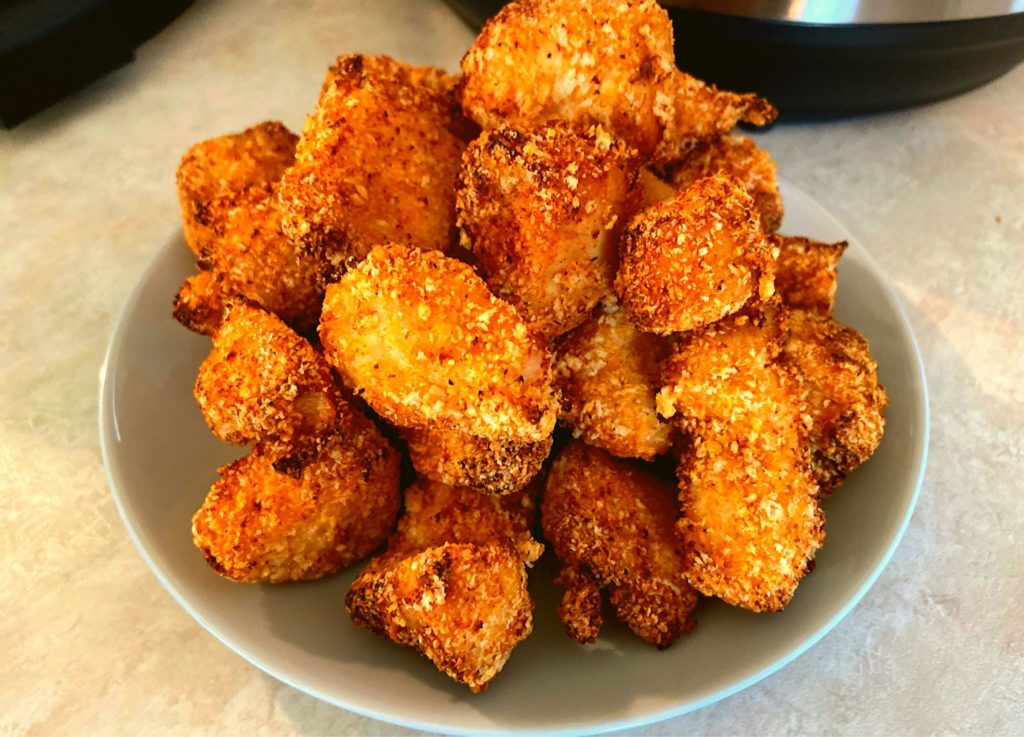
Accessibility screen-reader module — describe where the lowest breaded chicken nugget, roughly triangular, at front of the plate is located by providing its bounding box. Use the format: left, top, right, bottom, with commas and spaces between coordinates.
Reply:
345, 544, 534, 693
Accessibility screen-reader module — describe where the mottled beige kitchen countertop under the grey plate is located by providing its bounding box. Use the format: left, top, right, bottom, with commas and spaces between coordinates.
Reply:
0, 0, 1024, 735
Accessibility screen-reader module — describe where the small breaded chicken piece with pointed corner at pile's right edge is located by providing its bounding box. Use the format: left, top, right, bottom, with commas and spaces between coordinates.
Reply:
775, 235, 847, 315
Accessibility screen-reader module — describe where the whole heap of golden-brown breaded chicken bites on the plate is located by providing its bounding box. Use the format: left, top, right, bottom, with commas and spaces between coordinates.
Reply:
174, 0, 887, 691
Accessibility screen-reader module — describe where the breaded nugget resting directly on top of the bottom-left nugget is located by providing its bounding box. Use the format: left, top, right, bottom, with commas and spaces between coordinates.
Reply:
195, 303, 345, 456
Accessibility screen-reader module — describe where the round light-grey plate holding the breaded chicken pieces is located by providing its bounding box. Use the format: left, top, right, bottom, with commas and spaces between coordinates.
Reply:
99, 184, 928, 735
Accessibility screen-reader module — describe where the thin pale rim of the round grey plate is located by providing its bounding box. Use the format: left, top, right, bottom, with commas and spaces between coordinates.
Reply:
97, 177, 931, 737
